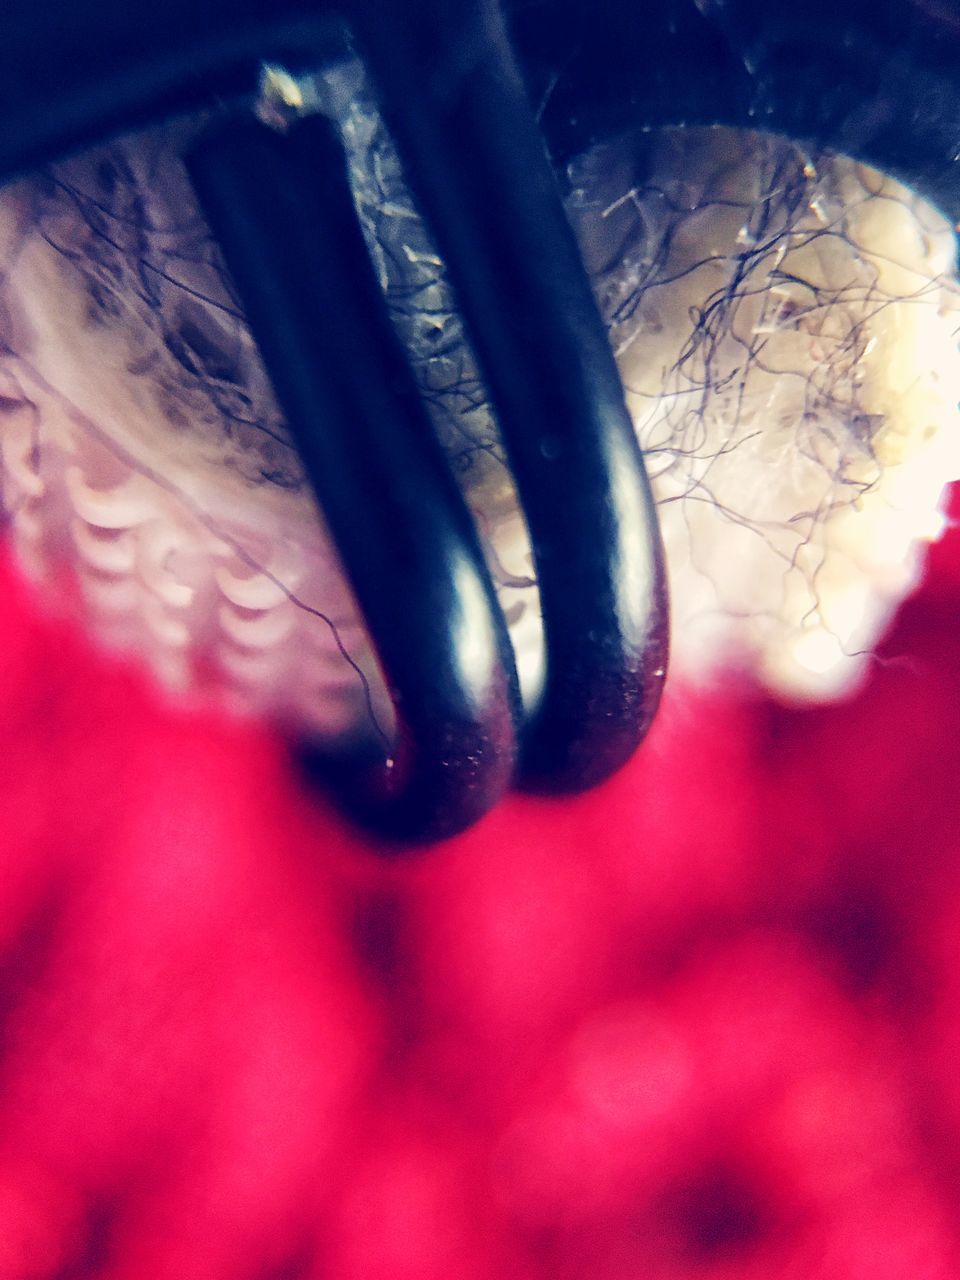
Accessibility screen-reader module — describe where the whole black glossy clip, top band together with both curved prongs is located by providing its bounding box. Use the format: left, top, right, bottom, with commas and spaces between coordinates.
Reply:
0, 0, 960, 840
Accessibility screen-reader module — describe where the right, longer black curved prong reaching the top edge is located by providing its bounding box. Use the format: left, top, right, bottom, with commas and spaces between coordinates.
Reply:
355, 0, 667, 790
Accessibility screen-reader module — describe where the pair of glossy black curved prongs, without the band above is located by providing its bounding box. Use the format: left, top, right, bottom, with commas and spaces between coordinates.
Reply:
188, 4, 667, 837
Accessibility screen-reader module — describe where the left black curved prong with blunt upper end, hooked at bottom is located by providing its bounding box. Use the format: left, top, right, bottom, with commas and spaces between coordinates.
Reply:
188, 116, 520, 840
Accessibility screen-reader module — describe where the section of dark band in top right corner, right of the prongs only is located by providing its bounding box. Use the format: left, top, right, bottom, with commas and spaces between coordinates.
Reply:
519, 0, 960, 220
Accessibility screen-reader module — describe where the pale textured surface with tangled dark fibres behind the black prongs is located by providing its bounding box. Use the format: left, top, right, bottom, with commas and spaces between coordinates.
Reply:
0, 74, 960, 736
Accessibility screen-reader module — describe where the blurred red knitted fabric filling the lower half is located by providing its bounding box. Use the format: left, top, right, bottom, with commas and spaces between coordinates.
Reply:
0, 491, 960, 1280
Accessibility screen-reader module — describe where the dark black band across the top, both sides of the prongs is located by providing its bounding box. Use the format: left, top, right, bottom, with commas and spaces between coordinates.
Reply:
0, 0, 960, 218
